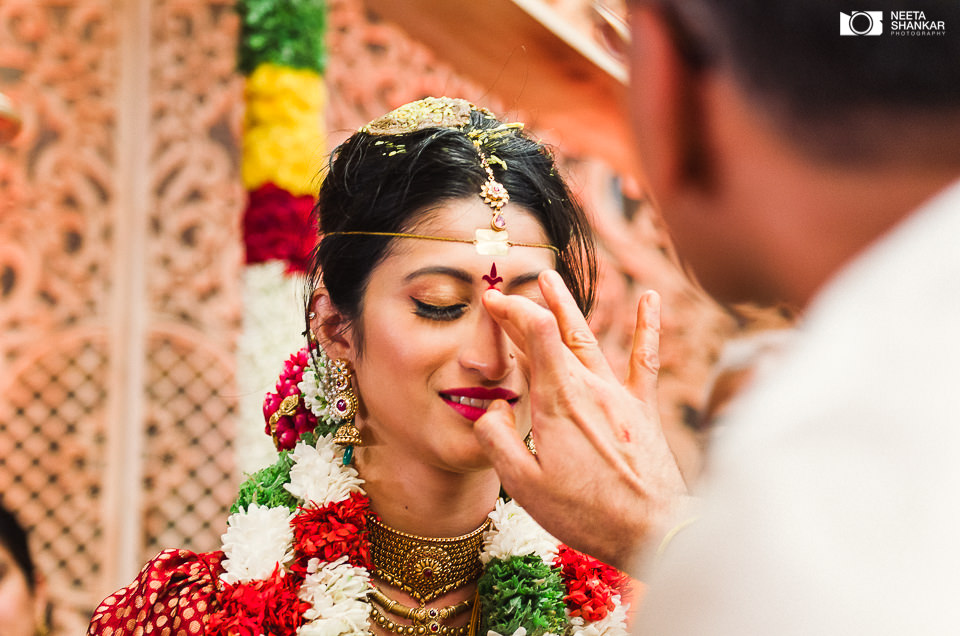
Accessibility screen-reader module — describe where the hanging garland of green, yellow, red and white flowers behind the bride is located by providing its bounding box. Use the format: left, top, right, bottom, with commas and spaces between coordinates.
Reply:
235, 0, 327, 472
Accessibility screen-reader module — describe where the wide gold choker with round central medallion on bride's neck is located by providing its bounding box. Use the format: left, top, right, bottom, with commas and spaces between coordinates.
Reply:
367, 515, 490, 605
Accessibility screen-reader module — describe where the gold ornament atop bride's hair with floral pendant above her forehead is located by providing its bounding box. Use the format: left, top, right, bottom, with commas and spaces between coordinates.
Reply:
360, 97, 523, 232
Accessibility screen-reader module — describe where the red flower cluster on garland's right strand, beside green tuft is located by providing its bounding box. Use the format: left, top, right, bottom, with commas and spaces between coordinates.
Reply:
553, 545, 630, 622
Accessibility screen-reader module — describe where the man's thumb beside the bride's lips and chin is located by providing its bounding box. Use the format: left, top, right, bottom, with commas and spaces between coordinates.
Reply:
473, 400, 540, 496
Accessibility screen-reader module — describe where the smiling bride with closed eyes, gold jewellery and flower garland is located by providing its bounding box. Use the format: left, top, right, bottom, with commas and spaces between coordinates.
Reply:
89, 98, 627, 636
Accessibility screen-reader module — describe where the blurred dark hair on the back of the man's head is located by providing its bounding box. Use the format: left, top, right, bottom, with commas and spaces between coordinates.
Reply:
635, 0, 960, 161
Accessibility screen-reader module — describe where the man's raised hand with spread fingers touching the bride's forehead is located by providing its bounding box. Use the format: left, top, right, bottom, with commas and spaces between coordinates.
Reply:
475, 271, 686, 569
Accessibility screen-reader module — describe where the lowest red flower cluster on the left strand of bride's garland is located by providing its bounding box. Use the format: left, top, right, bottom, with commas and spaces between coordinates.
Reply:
207, 566, 310, 636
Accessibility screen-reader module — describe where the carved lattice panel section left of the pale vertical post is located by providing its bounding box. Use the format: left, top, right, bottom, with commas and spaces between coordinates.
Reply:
0, 2, 118, 633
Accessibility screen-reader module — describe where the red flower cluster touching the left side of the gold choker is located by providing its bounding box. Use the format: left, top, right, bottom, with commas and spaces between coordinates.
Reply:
292, 492, 373, 573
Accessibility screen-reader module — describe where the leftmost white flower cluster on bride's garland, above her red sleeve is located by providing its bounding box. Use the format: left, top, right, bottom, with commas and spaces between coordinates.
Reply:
220, 503, 293, 584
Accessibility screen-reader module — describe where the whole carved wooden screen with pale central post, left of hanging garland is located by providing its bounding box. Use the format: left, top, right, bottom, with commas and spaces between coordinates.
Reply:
0, 0, 243, 634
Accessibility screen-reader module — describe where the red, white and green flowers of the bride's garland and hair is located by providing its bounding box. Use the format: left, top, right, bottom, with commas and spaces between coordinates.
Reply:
208, 348, 627, 636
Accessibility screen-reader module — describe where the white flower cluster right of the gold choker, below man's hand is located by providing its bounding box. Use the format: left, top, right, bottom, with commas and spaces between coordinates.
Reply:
480, 499, 559, 564
